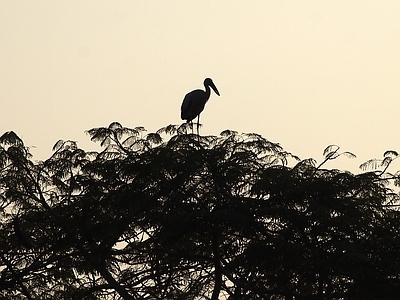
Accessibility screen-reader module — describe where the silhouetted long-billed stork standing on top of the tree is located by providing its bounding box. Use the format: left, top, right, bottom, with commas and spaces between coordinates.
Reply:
181, 78, 219, 135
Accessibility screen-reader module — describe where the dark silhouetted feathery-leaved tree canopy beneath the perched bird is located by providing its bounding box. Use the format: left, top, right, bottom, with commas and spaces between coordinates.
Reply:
0, 122, 400, 300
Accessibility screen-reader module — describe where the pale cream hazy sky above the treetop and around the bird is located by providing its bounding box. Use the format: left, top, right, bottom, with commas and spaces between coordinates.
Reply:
0, 0, 400, 169
